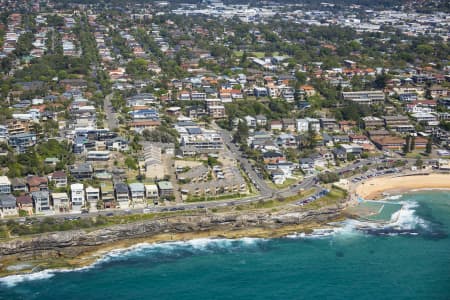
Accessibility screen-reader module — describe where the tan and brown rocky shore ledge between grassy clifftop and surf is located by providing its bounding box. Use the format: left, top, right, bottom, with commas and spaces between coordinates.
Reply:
0, 207, 345, 278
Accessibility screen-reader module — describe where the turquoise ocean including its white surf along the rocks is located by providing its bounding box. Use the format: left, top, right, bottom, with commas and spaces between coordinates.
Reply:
0, 191, 450, 300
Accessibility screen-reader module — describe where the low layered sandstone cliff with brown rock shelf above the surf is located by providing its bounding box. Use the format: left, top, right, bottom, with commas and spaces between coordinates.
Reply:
0, 206, 341, 275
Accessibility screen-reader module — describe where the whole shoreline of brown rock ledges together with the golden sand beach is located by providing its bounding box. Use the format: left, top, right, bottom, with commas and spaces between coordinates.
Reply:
0, 174, 450, 278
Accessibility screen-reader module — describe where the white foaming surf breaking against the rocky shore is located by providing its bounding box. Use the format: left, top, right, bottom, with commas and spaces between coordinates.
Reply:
0, 196, 445, 287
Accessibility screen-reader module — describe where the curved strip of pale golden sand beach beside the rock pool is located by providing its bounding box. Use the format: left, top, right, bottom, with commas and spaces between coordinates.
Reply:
355, 173, 450, 200
